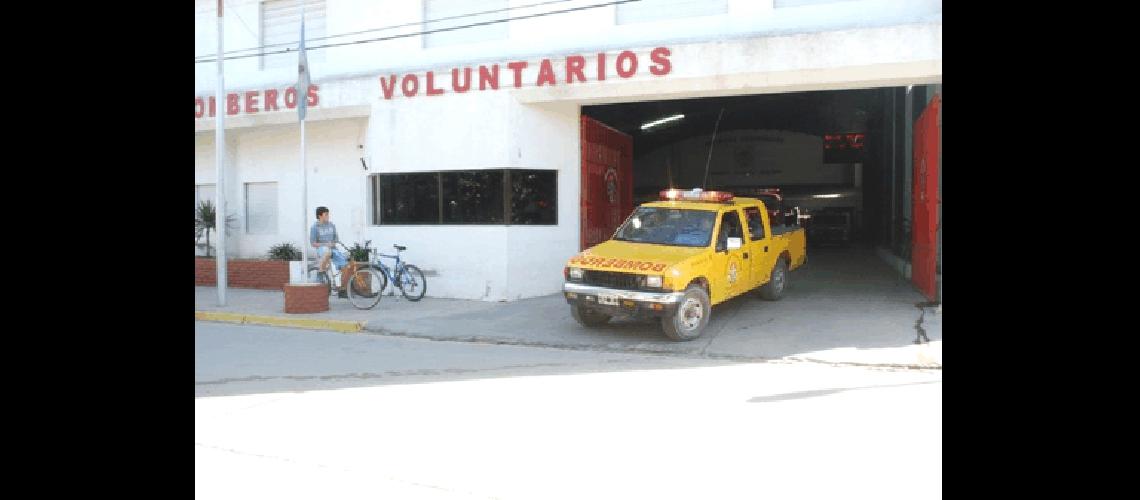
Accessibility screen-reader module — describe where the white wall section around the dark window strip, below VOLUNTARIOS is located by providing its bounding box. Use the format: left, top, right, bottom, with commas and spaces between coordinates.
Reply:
365, 93, 580, 301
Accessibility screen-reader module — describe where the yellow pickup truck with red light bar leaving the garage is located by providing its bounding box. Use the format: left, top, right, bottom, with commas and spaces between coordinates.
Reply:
562, 189, 807, 341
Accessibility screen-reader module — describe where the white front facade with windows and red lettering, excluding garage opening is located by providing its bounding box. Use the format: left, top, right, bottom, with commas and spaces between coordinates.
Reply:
195, 0, 942, 301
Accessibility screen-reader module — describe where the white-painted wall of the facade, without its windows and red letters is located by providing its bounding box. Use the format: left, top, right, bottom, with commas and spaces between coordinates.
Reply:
195, 0, 942, 301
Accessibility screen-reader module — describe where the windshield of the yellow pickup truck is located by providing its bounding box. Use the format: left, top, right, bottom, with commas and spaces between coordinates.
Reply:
613, 206, 716, 246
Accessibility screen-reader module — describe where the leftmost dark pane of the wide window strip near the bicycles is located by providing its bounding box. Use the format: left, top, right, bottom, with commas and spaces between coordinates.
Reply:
378, 173, 439, 224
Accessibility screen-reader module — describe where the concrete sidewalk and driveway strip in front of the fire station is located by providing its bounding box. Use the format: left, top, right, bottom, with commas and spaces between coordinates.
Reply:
194, 255, 942, 368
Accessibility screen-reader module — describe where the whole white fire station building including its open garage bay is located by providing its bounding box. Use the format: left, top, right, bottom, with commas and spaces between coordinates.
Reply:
194, 0, 942, 301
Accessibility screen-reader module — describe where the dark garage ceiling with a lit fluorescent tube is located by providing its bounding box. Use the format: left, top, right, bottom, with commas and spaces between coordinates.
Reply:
581, 89, 882, 157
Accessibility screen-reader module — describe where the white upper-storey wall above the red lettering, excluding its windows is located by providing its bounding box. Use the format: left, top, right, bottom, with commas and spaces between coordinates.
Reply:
195, 0, 942, 92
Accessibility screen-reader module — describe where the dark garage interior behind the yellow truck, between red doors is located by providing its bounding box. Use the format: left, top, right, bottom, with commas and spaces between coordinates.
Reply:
581, 85, 942, 301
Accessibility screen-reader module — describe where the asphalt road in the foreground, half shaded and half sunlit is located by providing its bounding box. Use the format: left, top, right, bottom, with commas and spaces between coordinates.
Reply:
195, 322, 942, 499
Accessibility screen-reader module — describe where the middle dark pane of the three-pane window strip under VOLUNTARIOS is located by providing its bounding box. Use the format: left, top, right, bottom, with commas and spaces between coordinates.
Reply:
440, 170, 504, 224
